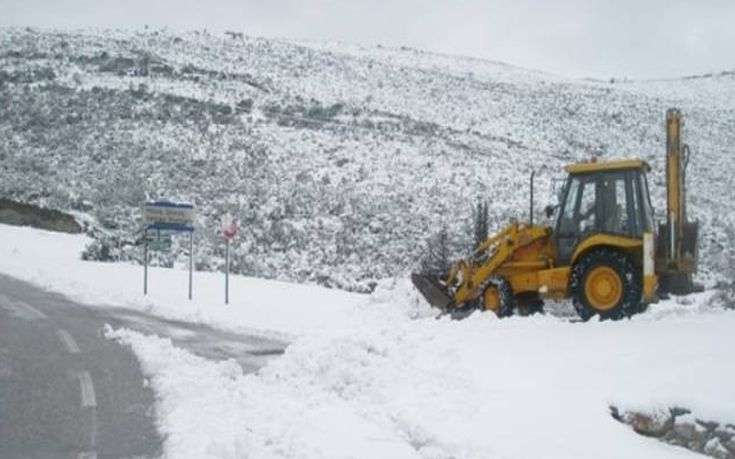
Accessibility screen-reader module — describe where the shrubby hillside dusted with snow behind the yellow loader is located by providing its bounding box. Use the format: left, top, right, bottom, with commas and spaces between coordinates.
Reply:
0, 29, 735, 291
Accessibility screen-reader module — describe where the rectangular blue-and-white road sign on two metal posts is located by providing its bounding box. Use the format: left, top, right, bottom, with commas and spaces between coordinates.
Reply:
143, 201, 194, 300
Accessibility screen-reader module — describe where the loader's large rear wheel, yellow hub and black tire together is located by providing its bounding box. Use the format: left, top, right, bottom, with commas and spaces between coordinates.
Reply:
571, 249, 643, 320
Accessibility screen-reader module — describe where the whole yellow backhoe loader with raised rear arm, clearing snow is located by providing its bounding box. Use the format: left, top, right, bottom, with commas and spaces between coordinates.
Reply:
412, 109, 698, 320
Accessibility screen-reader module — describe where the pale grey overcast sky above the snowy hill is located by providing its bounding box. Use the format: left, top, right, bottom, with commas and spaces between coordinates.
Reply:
0, 0, 735, 78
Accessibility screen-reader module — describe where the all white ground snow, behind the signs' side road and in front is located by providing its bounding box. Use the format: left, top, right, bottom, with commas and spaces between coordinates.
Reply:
0, 225, 735, 458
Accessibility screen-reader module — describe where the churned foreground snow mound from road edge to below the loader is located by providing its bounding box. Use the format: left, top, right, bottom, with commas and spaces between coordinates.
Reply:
108, 283, 735, 458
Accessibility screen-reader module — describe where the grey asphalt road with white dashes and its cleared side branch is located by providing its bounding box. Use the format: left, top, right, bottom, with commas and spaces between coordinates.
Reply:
0, 275, 286, 459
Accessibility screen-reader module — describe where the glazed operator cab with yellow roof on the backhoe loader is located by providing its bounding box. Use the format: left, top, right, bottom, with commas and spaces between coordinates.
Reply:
554, 160, 653, 265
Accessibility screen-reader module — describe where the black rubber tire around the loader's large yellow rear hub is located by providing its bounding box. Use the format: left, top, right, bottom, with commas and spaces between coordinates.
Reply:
570, 249, 643, 321
